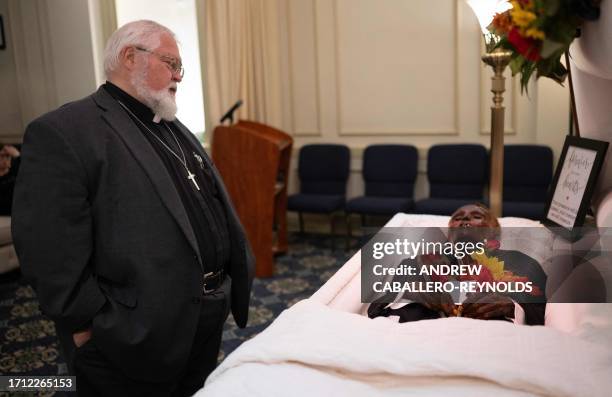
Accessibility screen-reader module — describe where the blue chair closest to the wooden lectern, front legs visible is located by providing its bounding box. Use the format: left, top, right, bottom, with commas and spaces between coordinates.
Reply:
287, 144, 351, 249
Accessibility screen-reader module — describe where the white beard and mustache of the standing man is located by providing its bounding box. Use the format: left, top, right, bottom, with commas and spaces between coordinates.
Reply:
131, 67, 177, 121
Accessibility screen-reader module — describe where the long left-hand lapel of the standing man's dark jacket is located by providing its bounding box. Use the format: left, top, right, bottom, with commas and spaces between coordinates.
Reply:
93, 87, 202, 266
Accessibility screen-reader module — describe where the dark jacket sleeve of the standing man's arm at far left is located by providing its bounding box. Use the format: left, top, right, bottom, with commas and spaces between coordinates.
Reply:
12, 121, 106, 331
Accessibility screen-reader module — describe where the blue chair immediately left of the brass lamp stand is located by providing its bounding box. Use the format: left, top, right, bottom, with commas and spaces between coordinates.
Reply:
414, 144, 488, 215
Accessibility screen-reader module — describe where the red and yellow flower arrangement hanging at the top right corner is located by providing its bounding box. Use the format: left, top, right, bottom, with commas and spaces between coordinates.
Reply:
488, 0, 600, 90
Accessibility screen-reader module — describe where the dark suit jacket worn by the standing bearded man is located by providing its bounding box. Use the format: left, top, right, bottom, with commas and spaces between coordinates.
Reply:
12, 88, 254, 380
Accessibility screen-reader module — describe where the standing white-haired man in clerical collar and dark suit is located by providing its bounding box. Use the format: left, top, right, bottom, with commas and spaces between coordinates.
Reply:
13, 21, 253, 396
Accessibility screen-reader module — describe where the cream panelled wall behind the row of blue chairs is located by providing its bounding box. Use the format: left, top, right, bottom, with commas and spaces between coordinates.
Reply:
280, 0, 568, 198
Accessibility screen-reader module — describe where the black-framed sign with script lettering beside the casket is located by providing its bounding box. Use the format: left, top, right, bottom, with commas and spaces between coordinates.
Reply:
542, 136, 608, 233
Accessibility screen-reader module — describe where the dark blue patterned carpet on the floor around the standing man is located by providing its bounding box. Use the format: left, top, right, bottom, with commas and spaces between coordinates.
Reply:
0, 233, 352, 386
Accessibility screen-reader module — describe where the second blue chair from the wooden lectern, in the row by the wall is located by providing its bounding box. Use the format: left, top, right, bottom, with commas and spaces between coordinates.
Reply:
346, 145, 419, 222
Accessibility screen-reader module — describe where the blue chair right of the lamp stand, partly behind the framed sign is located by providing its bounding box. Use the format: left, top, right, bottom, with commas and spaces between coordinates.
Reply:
502, 145, 553, 220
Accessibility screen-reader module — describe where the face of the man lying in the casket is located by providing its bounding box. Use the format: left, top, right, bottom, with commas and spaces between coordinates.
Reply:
448, 204, 499, 242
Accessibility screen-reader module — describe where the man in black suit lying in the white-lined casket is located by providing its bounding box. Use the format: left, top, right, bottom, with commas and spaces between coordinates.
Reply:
368, 204, 546, 325
